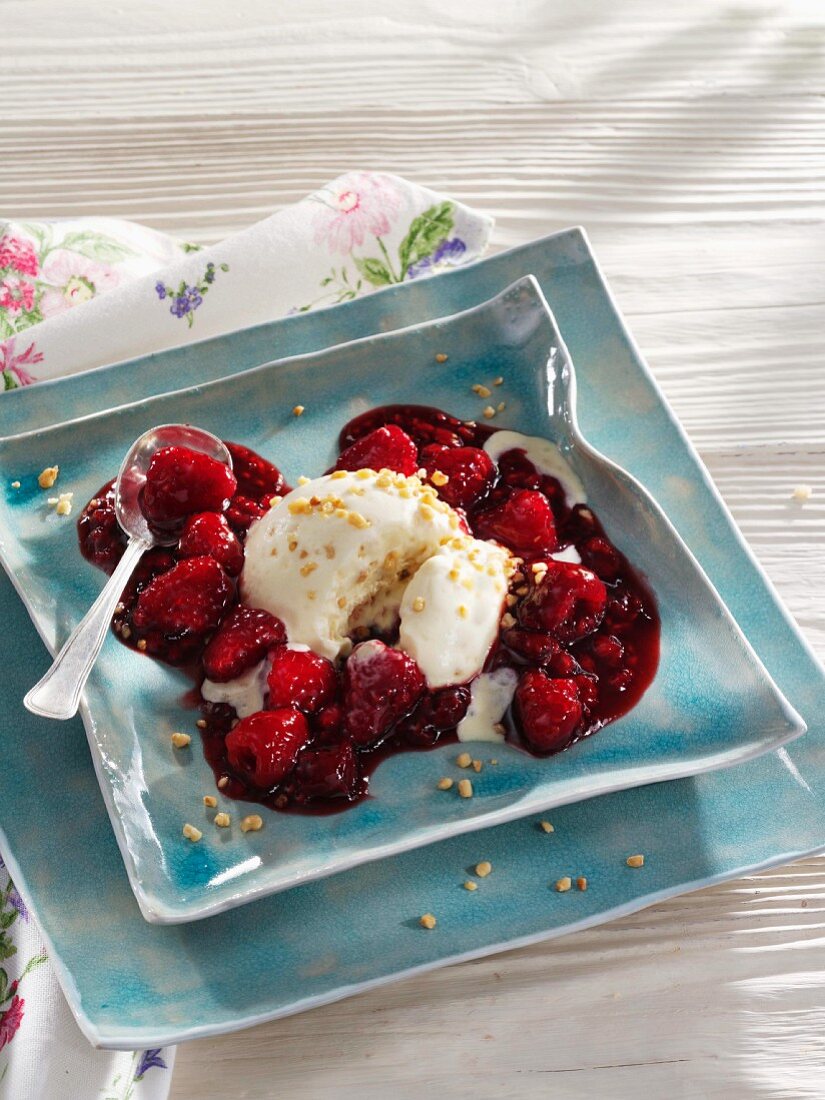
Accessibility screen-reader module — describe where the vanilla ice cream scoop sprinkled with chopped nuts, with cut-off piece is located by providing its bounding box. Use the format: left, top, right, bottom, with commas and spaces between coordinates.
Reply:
241, 470, 514, 688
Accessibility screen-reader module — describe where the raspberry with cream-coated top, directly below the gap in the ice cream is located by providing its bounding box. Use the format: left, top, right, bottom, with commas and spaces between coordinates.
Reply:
343, 639, 425, 746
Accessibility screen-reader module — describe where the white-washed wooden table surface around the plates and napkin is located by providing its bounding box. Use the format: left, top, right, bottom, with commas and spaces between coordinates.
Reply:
6, 0, 825, 1100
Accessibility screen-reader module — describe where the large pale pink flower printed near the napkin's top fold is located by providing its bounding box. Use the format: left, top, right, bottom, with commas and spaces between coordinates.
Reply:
312, 172, 402, 254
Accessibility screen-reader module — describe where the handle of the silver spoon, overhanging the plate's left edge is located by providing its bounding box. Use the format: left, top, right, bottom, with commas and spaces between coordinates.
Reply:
23, 538, 150, 719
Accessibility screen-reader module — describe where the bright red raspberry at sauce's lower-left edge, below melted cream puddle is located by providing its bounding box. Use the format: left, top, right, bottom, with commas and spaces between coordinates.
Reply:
227, 706, 309, 790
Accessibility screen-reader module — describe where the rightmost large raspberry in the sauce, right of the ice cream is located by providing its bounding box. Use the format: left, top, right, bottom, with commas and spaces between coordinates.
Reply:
518, 561, 607, 642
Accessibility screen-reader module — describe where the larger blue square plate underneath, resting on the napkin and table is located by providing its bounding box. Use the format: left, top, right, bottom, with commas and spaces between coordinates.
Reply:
0, 231, 825, 1049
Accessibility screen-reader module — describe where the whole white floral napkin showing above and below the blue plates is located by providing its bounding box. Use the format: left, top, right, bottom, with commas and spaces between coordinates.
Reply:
0, 172, 492, 1100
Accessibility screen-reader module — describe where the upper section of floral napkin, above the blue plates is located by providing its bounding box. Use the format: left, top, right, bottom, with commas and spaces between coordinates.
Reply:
0, 172, 492, 391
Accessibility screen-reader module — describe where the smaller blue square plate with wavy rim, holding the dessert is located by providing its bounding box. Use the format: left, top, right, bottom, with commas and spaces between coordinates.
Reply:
0, 278, 804, 923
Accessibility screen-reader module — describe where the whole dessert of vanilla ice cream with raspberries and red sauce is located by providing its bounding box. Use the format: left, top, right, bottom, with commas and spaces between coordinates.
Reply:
78, 406, 659, 812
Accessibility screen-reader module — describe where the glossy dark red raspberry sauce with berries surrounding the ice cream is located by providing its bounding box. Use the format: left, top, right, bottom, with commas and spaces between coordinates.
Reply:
77, 405, 660, 813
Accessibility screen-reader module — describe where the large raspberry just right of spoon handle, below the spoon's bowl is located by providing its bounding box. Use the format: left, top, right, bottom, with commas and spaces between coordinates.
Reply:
132, 557, 234, 639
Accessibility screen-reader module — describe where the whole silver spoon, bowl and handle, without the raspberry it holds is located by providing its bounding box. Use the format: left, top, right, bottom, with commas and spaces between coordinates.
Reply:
23, 424, 232, 719
